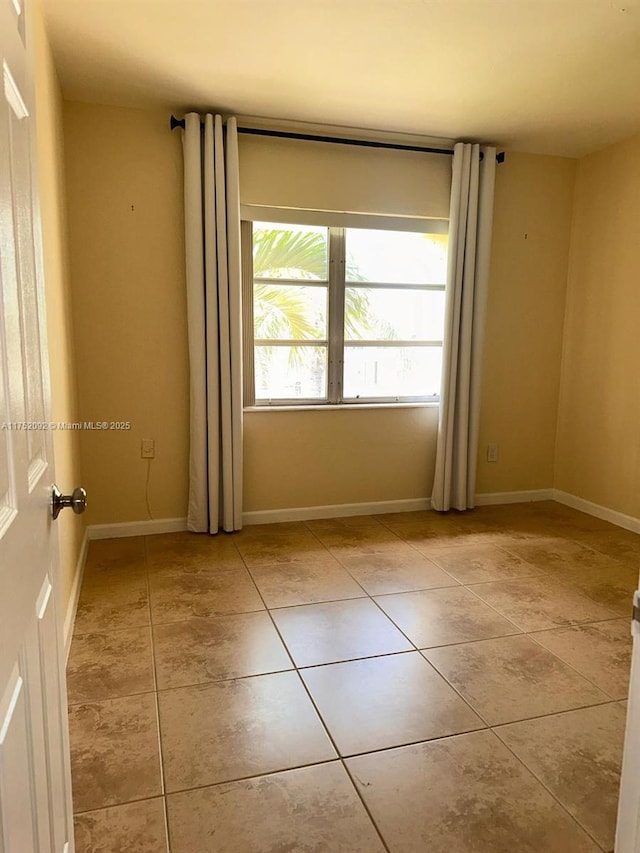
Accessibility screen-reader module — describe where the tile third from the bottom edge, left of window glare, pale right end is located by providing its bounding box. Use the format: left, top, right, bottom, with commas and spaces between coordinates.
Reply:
153, 612, 293, 690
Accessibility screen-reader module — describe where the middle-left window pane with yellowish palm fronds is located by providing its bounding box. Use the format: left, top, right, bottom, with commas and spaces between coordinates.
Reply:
253, 282, 328, 341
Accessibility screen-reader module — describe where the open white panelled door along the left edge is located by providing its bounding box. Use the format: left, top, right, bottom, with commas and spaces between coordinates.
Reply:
0, 0, 73, 853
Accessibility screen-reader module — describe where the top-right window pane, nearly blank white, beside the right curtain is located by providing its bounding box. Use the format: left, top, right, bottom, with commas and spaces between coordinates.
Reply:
345, 228, 449, 284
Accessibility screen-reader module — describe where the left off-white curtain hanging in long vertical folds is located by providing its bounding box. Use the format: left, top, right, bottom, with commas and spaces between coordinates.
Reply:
182, 113, 242, 533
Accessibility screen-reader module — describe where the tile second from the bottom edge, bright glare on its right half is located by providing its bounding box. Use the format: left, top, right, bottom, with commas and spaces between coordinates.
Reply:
158, 672, 335, 792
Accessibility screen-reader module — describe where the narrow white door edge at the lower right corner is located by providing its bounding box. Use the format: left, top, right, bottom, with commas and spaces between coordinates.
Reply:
616, 592, 640, 853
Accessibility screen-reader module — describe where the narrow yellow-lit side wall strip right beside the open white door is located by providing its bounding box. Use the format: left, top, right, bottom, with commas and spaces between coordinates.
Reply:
33, 6, 84, 613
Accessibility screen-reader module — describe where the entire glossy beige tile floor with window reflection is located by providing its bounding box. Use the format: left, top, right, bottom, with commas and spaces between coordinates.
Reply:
68, 503, 640, 853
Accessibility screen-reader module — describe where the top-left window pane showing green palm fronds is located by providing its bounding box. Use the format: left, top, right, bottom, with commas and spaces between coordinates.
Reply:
253, 222, 329, 281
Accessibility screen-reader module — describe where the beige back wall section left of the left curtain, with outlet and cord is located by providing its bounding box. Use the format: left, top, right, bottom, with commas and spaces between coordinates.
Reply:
64, 103, 189, 524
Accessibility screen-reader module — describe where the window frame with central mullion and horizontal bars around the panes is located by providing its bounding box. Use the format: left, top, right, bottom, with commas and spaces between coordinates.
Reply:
241, 211, 449, 409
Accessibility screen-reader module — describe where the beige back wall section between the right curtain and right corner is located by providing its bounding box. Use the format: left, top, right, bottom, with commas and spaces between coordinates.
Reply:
477, 152, 576, 493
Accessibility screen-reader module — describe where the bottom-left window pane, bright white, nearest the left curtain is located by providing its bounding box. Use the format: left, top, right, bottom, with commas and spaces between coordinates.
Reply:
255, 346, 327, 400
